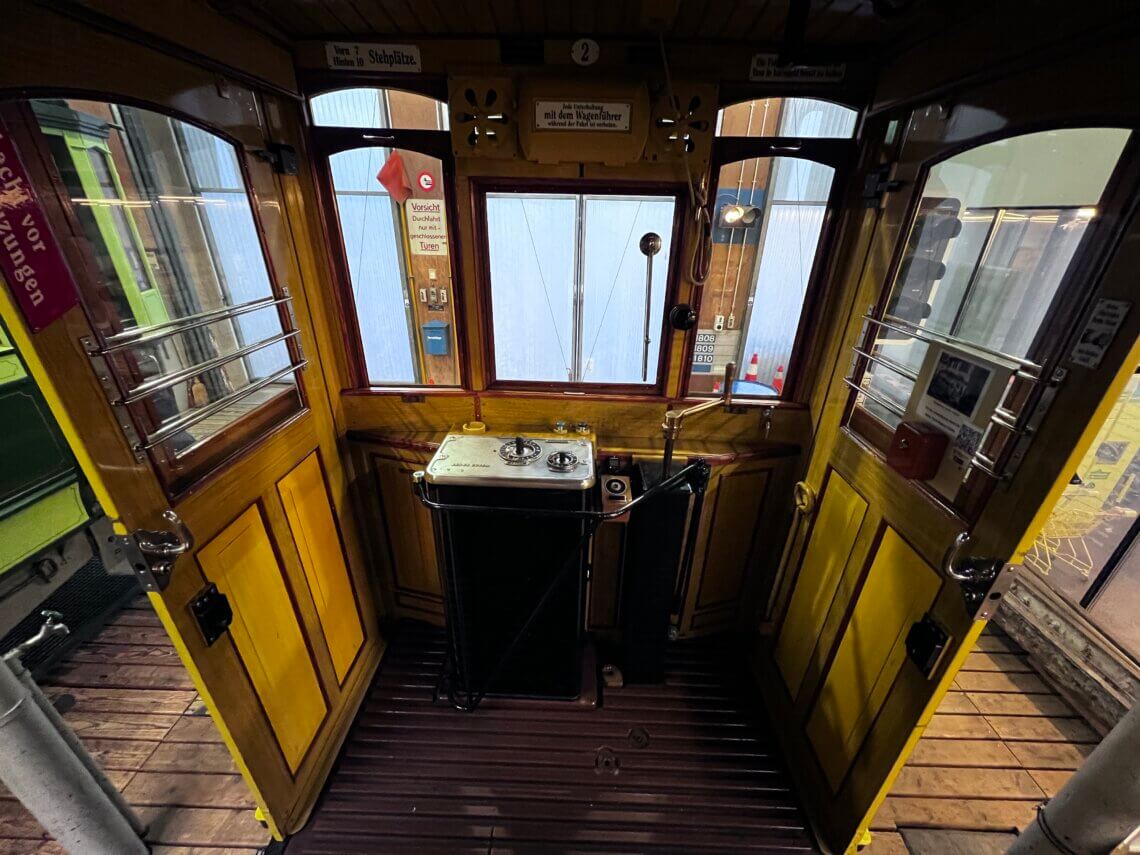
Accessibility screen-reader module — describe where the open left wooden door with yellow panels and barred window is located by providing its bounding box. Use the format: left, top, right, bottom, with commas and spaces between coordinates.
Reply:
0, 78, 383, 838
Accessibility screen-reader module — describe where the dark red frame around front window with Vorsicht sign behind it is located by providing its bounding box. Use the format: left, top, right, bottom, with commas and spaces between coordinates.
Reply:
304, 93, 470, 396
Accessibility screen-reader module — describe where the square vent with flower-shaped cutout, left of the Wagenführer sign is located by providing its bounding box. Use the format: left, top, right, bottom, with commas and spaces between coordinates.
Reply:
448, 78, 519, 157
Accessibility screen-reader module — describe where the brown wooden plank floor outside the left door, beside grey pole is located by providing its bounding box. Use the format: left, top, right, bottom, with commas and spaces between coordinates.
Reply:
0, 599, 269, 855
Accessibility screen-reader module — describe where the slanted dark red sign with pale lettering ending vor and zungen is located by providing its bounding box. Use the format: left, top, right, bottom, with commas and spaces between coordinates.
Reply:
0, 122, 79, 332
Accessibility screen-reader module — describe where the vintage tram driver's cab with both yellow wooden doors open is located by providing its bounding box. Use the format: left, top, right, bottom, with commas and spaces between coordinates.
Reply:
0, 0, 1140, 853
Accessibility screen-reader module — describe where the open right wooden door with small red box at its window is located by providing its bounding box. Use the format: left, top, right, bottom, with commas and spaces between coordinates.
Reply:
757, 58, 1140, 852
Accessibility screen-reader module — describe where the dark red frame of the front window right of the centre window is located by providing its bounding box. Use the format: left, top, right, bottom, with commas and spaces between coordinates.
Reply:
681, 132, 860, 407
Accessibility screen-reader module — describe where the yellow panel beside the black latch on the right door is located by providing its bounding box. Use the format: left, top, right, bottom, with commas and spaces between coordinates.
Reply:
807, 528, 942, 791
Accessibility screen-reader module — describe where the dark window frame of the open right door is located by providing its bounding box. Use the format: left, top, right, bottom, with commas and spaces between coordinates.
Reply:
840, 120, 1140, 523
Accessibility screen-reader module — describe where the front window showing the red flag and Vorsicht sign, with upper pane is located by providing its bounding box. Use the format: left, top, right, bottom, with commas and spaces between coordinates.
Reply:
310, 89, 459, 388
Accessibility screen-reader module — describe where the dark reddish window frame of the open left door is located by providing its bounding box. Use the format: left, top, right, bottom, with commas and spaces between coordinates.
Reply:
0, 96, 309, 500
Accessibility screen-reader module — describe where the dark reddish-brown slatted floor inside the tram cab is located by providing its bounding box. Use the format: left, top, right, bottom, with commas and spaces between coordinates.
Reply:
286, 625, 812, 855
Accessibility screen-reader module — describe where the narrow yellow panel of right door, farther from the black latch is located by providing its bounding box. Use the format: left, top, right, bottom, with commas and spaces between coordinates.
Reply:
775, 471, 866, 699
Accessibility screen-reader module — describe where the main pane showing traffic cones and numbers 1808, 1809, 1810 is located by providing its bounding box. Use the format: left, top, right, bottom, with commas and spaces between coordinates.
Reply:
689, 157, 834, 398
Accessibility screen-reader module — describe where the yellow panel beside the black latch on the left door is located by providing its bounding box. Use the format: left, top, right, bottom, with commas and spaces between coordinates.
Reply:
198, 505, 327, 771
